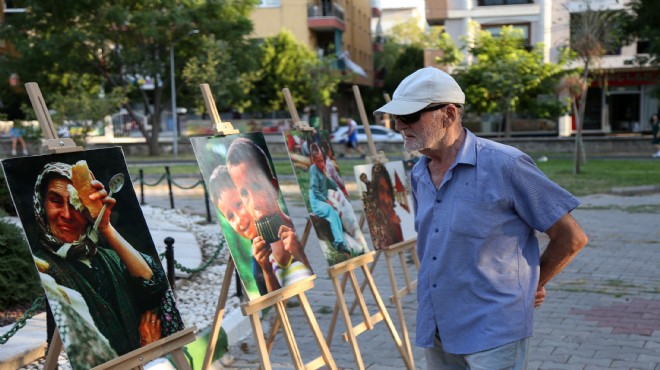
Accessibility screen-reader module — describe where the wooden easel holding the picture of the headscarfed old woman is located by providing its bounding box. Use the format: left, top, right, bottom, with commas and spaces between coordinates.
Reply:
25, 82, 197, 370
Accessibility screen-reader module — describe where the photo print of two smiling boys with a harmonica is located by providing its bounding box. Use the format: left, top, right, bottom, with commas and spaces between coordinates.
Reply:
191, 132, 313, 300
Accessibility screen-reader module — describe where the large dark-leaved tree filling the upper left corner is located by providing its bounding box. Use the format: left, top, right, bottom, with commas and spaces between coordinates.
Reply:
0, 0, 254, 155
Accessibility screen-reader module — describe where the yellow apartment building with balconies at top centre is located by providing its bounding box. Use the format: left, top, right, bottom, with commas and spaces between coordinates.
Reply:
252, 0, 373, 86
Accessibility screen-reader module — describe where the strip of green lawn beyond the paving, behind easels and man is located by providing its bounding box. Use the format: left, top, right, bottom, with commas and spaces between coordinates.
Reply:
126, 153, 660, 196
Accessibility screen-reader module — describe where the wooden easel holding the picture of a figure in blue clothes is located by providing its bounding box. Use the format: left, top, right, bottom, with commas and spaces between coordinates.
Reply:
282, 88, 414, 370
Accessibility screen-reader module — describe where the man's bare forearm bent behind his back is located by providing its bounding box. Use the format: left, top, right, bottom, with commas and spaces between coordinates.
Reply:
536, 213, 589, 306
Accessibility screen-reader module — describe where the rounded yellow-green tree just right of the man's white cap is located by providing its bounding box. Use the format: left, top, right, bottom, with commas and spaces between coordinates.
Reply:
456, 26, 567, 137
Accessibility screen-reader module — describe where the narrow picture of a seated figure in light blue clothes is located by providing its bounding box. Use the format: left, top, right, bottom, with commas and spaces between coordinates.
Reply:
284, 130, 369, 266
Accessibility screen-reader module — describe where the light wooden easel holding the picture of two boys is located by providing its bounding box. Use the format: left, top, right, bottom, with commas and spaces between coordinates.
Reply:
200, 84, 337, 370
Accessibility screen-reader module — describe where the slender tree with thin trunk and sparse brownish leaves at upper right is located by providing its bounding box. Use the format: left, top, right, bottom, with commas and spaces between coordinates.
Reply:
570, 0, 621, 174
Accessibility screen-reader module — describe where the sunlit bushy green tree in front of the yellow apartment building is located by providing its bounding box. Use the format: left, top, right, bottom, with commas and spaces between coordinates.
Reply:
247, 30, 342, 125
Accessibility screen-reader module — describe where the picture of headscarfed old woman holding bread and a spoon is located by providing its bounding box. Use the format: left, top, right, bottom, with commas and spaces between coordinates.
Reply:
2, 148, 184, 370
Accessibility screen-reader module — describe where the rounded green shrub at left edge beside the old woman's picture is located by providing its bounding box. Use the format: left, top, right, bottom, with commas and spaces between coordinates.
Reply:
0, 215, 44, 311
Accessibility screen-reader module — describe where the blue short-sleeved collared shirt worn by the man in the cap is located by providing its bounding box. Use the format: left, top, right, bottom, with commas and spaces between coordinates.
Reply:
412, 129, 579, 354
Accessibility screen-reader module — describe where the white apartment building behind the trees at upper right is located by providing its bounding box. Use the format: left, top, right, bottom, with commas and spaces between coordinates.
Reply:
426, 0, 660, 134
